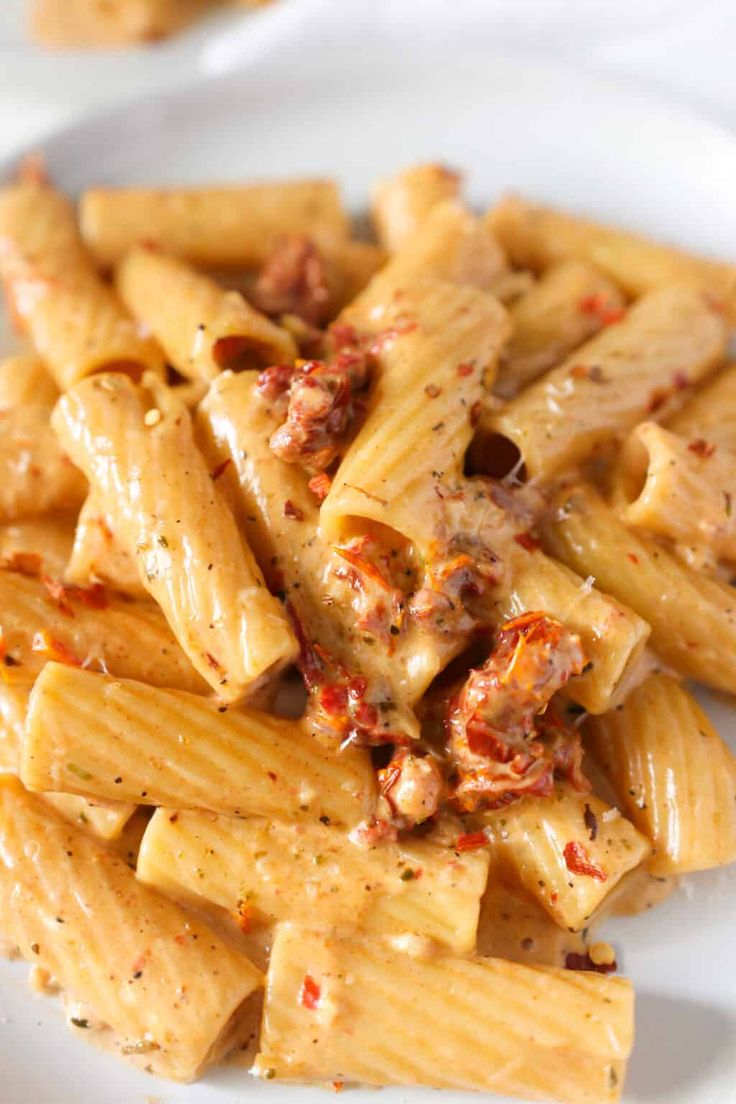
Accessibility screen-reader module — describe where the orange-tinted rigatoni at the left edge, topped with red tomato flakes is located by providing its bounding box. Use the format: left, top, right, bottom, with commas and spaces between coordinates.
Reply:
0, 571, 206, 693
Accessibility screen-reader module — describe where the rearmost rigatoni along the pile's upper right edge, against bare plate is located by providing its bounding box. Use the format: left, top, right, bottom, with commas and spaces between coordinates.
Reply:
488, 195, 736, 316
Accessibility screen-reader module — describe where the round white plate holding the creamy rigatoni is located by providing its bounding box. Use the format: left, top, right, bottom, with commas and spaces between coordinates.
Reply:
0, 10, 736, 1104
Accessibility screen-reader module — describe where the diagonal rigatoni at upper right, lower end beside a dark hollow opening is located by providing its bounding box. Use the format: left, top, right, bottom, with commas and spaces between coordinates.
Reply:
484, 286, 728, 479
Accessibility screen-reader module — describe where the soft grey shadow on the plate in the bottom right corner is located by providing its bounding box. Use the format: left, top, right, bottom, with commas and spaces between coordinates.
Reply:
627, 992, 736, 1104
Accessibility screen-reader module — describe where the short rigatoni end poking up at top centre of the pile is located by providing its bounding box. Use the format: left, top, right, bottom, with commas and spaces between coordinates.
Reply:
371, 162, 462, 253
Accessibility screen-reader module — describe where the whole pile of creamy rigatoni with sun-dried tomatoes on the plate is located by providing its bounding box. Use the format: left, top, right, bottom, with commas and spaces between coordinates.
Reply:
0, 162, 736, 1104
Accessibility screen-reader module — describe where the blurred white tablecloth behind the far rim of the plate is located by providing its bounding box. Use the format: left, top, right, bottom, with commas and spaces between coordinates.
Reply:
0, 0, 736, 157
